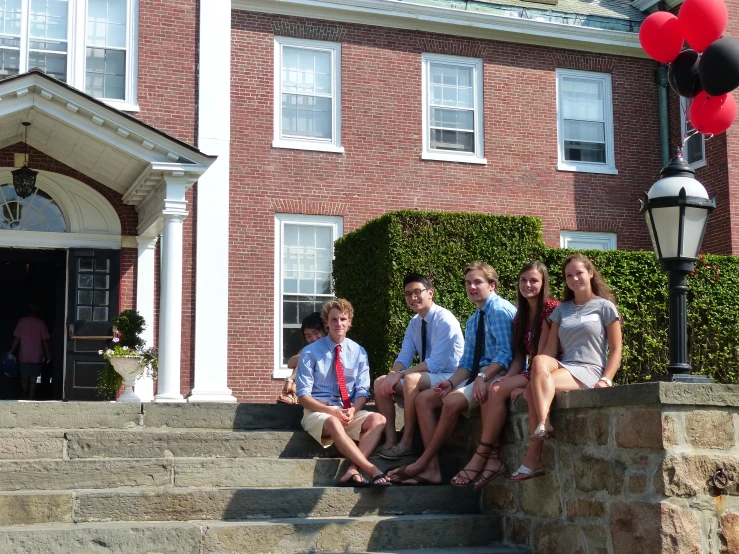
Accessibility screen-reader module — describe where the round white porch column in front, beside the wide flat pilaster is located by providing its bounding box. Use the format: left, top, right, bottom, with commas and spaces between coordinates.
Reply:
155, 181, 187, 402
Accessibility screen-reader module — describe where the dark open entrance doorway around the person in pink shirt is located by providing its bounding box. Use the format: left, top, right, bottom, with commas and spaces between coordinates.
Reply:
0, 248, 67, 400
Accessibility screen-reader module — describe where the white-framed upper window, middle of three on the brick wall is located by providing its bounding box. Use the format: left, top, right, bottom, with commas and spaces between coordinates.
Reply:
421, 54, 487, 164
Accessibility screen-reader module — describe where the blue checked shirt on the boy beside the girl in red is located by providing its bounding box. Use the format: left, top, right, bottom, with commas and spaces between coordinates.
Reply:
459, 293, 516, 373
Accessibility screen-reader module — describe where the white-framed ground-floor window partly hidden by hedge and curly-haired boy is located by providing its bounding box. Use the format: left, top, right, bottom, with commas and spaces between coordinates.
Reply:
274, 214, 344, 378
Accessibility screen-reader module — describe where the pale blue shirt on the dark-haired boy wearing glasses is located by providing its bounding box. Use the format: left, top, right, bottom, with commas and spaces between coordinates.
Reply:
395, 304, 464, 373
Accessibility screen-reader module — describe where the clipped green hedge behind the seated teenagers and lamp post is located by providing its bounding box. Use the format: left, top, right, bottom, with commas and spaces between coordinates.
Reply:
333, 211, 739, 383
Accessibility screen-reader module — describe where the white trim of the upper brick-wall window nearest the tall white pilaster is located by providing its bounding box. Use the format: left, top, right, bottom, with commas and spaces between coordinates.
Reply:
272, 37, 344, 154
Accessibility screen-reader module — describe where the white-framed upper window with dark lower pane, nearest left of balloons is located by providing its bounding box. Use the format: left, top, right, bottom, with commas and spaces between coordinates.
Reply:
556, 69, 618, 175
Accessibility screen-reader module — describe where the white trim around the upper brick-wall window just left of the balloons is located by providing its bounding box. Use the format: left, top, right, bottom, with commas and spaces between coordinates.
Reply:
556, 69, 618, 175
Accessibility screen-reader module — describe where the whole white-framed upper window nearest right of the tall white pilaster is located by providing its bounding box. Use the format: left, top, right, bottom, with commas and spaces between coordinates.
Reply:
272, 37, 344, 153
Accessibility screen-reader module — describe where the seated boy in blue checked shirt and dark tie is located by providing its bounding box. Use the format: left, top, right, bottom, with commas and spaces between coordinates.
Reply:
388, 262, 516, 485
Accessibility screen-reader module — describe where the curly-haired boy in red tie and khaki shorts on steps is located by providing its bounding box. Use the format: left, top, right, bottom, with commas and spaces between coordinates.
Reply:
297, 298, 391, 487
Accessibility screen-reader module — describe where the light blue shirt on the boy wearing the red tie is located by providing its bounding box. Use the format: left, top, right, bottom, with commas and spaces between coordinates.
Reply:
295, 337, 370, 406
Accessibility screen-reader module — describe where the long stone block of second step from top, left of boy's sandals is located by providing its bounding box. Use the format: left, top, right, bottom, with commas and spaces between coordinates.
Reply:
66, 427, 338, 459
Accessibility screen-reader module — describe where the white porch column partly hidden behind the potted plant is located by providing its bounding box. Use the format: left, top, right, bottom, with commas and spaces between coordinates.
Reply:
133, 237, 158, 402
